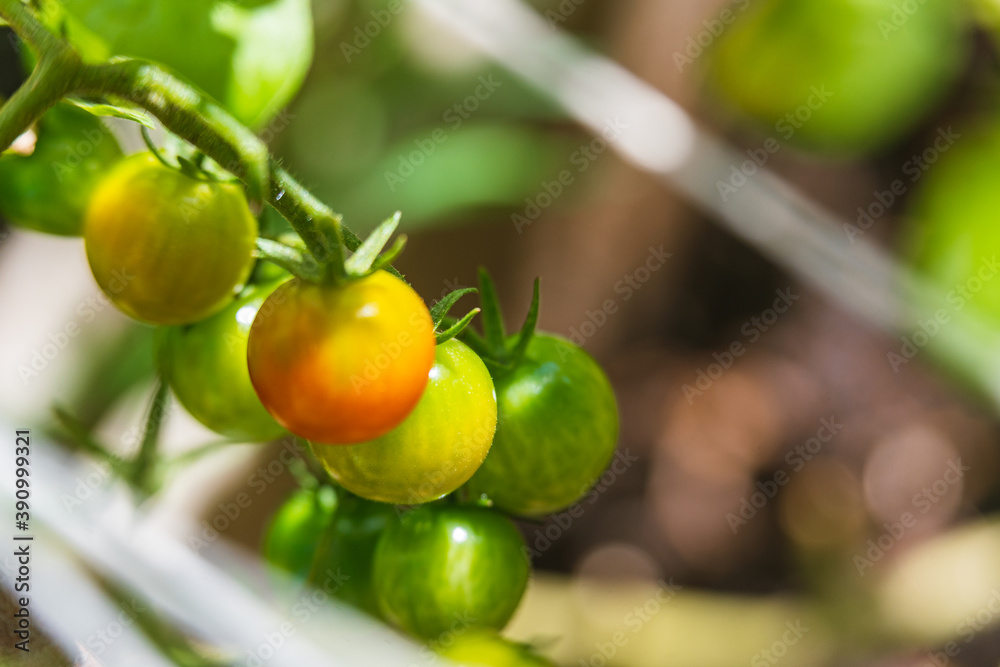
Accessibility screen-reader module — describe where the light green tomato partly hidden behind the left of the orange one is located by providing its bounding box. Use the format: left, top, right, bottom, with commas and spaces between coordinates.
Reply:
160, 284, 286, 442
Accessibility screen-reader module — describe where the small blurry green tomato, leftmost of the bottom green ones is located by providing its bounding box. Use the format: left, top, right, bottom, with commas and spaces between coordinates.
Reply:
264, 486, 337, 581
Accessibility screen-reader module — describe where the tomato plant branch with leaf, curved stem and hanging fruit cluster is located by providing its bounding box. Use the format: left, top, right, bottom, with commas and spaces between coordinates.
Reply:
0, 0, 632, 667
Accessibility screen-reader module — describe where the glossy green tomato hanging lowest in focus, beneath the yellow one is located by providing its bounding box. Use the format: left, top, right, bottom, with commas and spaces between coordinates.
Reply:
372, 503, 530, 639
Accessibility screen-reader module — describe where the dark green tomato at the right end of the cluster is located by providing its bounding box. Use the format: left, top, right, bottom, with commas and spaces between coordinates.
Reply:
469, 334, 618, 517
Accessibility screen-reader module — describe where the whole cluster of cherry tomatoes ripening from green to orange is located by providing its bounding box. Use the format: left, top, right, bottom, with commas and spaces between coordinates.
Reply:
0, 107, 618, 665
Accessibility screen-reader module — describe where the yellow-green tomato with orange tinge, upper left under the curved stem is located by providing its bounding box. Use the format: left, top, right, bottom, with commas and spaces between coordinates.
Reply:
84, 153, 257, 325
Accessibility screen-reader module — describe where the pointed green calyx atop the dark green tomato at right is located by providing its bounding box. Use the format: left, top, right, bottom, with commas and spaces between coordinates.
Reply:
461, 268, 540, 377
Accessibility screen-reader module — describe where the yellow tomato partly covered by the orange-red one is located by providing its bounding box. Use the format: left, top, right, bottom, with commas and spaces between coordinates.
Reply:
313, 339, 497, 505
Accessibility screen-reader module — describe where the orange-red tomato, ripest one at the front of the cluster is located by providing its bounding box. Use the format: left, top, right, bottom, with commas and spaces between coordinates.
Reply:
248, 271, 435, 445
